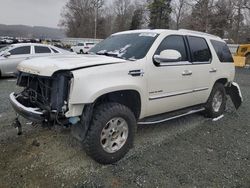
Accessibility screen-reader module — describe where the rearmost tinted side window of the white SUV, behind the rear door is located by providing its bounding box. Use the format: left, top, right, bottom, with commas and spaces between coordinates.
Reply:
211, 40, 234, 63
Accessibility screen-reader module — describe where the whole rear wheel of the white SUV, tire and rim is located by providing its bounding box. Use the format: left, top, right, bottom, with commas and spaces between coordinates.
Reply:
205, 83, 227, 118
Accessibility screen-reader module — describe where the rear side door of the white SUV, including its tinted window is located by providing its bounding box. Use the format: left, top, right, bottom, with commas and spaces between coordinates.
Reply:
187, 36, 217, 104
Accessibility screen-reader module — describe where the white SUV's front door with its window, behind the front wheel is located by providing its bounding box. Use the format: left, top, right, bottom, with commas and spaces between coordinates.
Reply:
147, 35, 195, 116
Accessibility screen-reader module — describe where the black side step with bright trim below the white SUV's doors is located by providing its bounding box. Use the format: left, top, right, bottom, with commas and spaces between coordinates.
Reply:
137, 106, 205, 125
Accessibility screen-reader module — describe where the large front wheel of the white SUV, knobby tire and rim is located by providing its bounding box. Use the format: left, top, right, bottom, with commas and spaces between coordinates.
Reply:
84, 103, 136, 164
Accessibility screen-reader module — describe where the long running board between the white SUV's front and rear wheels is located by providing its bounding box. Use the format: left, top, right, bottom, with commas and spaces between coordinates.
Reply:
137, 107, 205, 125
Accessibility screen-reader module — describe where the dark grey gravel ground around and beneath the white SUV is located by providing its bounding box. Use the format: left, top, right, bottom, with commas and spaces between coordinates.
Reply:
0, 69, 250, 188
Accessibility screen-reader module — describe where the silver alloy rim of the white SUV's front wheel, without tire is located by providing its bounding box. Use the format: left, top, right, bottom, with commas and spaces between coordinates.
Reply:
100, 117, 128, 153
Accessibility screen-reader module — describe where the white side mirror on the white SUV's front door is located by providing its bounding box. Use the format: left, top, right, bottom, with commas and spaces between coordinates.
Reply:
154, 50, 182, 63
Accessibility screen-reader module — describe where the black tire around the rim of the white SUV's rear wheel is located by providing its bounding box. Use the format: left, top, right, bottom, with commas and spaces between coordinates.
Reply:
205, 83, 227, 118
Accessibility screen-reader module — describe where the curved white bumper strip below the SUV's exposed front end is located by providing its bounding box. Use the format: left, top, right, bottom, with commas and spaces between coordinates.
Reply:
10, 93, 45, 122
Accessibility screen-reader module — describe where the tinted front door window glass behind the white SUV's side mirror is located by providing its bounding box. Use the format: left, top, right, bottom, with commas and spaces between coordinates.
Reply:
155, 35, 187, 61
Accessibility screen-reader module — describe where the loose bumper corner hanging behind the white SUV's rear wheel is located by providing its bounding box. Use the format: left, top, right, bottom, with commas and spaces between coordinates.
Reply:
226, 82, 243, 109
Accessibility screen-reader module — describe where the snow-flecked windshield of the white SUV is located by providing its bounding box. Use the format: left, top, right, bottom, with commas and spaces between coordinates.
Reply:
89, 32, 158, 60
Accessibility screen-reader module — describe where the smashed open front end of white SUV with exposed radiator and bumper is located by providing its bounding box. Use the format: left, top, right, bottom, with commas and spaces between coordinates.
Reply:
10, 72, 73, 124
